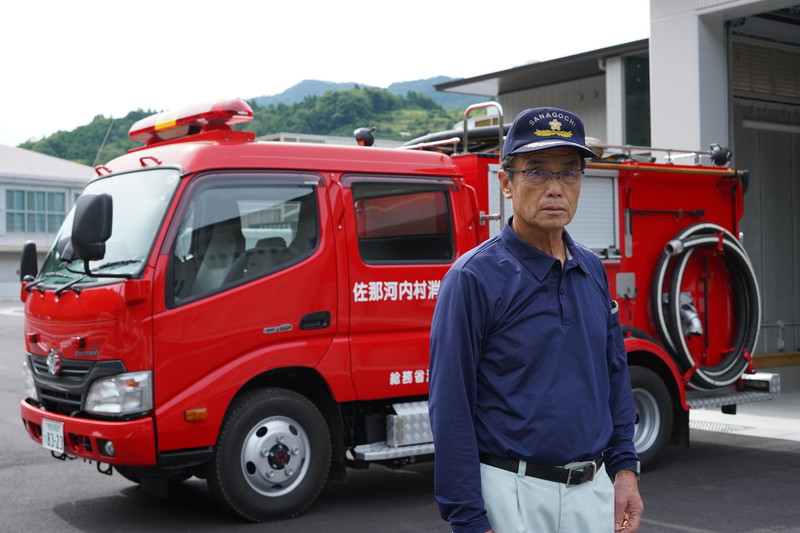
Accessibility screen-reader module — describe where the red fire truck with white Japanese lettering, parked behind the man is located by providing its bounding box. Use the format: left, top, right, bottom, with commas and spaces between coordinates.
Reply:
20, 100, 780, 521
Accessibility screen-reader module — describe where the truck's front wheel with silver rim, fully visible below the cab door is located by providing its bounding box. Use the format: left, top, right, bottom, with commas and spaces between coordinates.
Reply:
207, 389, 331, 522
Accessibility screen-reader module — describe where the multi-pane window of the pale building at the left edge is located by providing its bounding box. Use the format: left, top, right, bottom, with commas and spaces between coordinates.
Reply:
6, 189, 66, 233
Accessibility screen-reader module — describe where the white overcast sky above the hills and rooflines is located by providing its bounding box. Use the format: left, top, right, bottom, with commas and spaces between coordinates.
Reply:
0, 0, 650, 146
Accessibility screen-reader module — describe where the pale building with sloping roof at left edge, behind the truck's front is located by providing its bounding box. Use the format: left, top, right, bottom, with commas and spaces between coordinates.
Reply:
0, 145, 92, 300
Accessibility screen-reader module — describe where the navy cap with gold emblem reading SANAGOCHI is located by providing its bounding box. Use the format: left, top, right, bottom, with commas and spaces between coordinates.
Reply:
503, 107, 597, 158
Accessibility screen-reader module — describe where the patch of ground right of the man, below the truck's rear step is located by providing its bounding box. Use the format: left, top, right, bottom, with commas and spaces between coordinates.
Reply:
639, 414, 800, 533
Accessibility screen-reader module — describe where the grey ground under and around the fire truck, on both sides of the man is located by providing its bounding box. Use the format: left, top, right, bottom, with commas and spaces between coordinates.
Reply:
0, 304, 800, 533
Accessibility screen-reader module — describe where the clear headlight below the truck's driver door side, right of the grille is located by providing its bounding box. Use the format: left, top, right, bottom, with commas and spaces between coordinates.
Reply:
84, 371, 153, 415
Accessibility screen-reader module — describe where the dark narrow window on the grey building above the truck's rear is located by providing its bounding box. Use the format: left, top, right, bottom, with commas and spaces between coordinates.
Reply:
624, 52, 650, 146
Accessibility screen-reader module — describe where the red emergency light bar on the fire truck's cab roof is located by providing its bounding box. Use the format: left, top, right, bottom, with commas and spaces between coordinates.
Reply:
128, 99, 255, 146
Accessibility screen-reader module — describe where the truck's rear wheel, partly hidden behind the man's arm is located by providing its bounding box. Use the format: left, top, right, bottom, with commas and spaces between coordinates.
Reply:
629, 366, 673, 467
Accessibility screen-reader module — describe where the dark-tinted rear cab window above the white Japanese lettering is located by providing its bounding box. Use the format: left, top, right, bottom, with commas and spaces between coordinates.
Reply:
353, 182, 454, 264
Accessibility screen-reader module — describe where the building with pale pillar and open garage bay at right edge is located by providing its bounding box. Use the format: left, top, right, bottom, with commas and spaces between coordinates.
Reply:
650, 0, 800, 353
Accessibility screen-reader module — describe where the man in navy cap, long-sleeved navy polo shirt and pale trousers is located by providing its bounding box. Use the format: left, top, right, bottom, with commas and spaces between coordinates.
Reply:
429, 108, 644, 533
